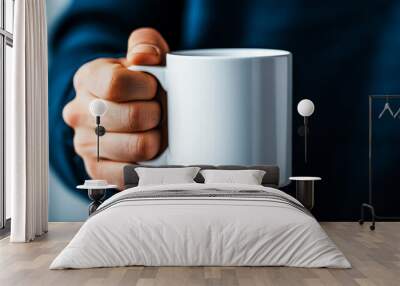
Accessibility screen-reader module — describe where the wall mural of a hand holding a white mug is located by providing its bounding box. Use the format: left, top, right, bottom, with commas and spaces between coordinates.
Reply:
48, 0, 400, 220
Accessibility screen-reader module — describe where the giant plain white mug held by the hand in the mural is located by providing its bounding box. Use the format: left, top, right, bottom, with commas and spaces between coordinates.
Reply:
129, 49, 292, 185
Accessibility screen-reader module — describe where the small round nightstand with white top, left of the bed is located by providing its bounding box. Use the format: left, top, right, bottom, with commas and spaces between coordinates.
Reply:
76, 180, 117, 215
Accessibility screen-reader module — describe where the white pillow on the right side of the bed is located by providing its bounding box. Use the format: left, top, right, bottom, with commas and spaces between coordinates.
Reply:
200, 170, 265, 185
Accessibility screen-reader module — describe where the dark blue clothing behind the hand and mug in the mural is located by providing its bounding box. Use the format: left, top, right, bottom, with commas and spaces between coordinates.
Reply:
49, 0, 400, 220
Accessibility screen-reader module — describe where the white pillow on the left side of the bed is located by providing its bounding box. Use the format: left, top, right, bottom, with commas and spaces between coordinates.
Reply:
135, 167, 200, 186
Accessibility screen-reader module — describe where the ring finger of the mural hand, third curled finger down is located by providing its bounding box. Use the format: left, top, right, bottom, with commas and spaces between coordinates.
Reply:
74, 128, 160, 163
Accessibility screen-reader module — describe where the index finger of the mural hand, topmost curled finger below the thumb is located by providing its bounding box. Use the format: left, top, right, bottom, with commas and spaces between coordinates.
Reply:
74, 59, 157, 102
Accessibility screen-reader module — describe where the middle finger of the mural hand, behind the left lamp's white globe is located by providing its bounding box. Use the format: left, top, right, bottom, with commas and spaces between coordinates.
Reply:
63, 92, 161, 132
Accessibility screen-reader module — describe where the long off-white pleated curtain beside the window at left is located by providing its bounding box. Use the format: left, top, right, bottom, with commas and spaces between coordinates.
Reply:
6, 0, 48, 242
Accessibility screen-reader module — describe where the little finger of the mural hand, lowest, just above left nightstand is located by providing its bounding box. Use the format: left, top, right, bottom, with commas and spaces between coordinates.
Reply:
84, 158, 126, 190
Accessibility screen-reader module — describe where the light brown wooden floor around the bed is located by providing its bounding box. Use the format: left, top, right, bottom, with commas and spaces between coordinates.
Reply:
0, 222, 400, 286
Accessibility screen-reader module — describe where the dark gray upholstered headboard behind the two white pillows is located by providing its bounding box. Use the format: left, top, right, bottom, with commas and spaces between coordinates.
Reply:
124, 165, 279, 189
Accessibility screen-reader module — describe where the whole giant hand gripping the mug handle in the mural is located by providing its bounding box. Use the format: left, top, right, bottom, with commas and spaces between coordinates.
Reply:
63, 28, 169, 187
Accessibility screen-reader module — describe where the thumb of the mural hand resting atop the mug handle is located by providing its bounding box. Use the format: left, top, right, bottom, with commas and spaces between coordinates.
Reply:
126, 28, 169, 65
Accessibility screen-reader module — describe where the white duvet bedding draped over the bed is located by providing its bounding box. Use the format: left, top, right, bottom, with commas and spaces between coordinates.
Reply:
50, 183, 351, 269
